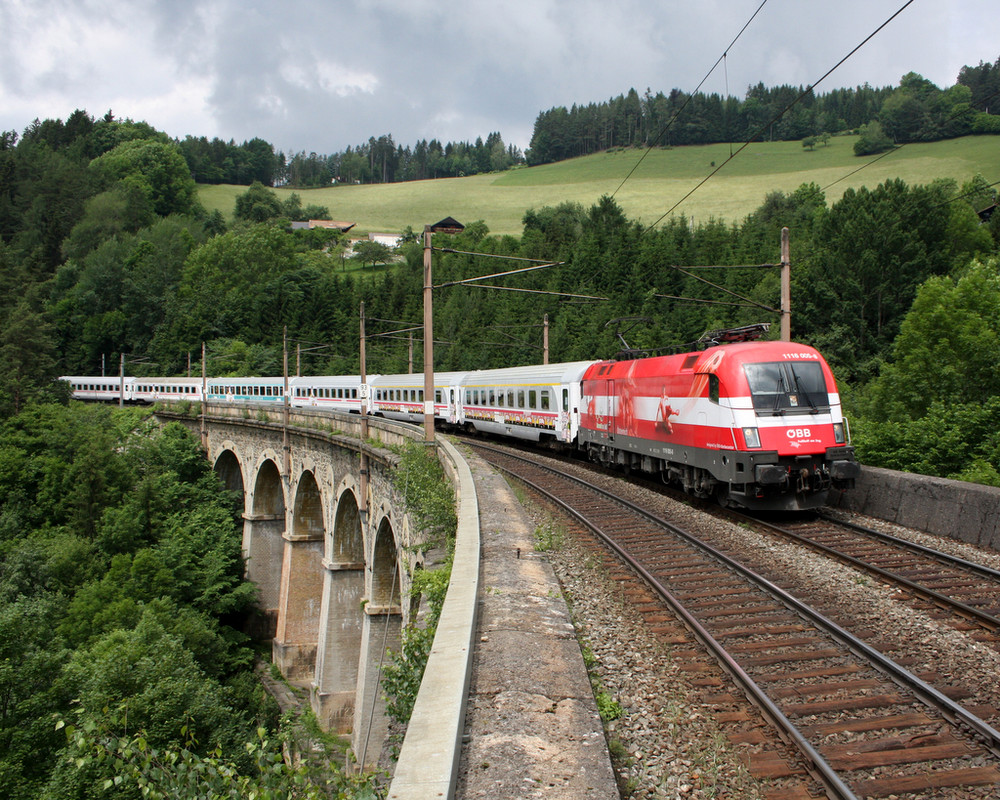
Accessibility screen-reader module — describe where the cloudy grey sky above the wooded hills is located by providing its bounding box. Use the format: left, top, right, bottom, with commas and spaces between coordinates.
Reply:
0, 0, 1000, 154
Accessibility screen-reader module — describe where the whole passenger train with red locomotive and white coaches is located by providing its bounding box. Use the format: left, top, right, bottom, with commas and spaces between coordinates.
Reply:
63, 332, 860, 511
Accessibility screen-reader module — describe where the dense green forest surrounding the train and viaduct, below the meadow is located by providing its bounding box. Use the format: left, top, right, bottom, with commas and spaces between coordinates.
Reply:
0, 54, 1000, 800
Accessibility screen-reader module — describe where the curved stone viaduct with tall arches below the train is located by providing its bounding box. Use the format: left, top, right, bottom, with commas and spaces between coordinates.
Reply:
164, 404, 441, 764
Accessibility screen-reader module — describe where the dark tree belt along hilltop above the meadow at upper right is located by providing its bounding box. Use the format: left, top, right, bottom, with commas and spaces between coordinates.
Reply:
525, 59, 1000, 165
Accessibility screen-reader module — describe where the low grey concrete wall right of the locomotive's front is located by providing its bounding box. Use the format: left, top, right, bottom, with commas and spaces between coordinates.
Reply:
830, 467, 1000, 550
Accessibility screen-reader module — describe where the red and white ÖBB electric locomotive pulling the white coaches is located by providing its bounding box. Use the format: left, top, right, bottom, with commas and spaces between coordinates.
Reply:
579, 326, 860, 510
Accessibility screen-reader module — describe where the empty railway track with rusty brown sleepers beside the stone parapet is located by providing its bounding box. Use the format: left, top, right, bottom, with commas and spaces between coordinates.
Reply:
477, 446, 1000, 798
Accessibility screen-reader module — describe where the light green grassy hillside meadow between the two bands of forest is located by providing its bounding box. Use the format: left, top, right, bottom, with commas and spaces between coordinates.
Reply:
199, 136, 1000, 235
